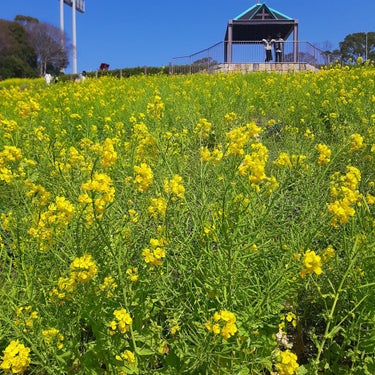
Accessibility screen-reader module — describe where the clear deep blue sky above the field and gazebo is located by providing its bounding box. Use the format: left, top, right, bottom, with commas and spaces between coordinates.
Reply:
0, 0, 375, 73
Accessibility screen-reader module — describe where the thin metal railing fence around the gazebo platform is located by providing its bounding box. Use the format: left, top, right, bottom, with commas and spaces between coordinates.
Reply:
170, 41, 330, 74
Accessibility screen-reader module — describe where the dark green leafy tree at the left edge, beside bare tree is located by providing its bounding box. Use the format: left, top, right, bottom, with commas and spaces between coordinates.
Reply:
0, 20, 37, 79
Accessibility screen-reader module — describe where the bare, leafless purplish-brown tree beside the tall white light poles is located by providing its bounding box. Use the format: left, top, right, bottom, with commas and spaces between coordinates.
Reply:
15, 15, 69, 76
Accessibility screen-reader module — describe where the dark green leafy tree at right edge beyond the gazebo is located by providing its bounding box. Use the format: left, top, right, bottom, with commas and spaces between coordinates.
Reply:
339, 32, 375, 62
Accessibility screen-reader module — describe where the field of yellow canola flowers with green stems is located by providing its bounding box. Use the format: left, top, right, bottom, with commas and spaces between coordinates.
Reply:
0, 64, 375, 375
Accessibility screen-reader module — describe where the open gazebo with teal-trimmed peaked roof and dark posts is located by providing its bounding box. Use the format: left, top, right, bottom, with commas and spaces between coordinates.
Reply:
224, 2, 298, 63
